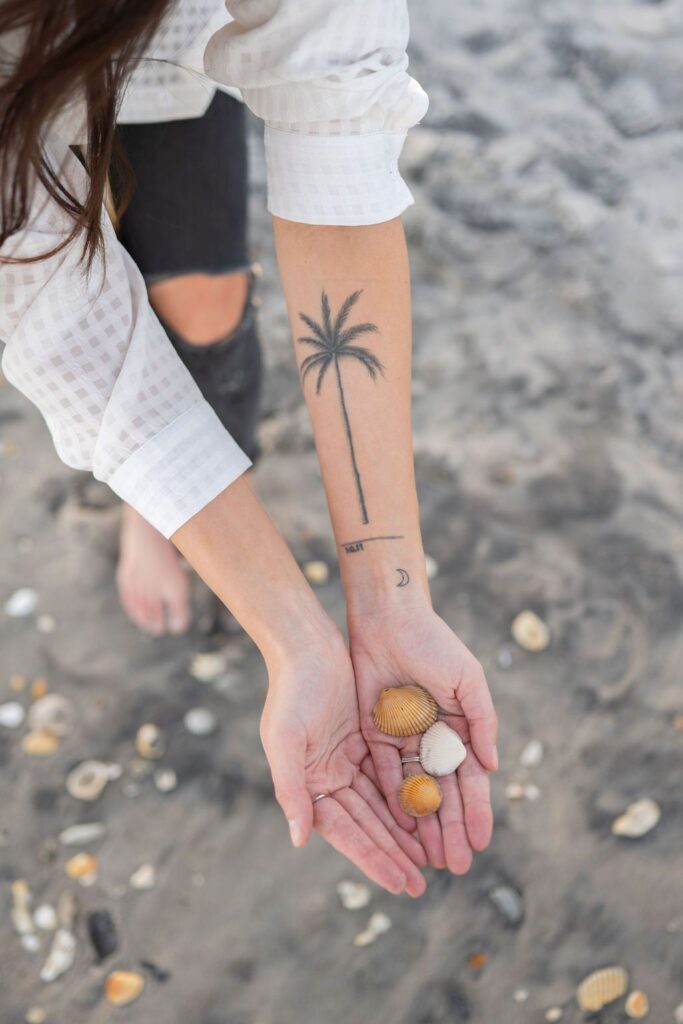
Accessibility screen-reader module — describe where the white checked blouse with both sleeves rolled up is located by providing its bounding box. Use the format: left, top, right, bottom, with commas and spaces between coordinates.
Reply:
0, 0, 427, 537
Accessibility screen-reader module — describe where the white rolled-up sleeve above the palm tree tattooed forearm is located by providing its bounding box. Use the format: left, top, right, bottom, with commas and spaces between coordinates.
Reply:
205, 0, 427, 225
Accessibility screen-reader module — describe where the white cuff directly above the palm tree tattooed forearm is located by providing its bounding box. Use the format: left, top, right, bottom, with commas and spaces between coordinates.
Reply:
265, 126, 413, 225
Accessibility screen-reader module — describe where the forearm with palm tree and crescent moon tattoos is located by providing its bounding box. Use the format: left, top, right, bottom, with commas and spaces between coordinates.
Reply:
273, 218, 429, 617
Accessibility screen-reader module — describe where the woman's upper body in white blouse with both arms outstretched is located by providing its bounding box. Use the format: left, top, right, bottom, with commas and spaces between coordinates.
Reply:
0, 0, 497, 895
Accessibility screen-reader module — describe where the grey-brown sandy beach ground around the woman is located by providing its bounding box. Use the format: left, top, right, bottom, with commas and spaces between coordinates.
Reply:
0, 0, 683, 1024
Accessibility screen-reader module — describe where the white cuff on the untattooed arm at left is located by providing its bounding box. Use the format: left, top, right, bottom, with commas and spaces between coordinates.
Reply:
101, 401, 251, 538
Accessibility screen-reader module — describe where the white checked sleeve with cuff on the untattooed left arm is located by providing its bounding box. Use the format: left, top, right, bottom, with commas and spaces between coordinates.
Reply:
0, 140, 251, 537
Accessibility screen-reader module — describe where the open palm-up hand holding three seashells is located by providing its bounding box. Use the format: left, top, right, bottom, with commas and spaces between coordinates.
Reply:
349, 601, 498, 874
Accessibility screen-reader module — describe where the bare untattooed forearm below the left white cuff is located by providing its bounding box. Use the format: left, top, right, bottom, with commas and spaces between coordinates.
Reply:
172, 476, 336, 670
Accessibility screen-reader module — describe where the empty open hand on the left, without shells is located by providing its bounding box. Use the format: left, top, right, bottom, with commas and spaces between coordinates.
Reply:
261, 629, 426, 896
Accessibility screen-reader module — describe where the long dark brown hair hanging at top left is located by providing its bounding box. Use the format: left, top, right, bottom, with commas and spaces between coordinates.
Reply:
0, 0, 173, 265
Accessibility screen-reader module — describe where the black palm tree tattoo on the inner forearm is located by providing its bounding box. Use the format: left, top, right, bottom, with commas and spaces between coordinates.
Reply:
297, 289, 384, 523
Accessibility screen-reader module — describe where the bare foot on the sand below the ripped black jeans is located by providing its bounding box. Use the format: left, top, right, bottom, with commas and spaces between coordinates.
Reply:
116, 505, 191, 636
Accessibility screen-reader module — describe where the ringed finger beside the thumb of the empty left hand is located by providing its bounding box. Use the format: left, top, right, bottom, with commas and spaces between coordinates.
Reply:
315, 795, 407, 895
